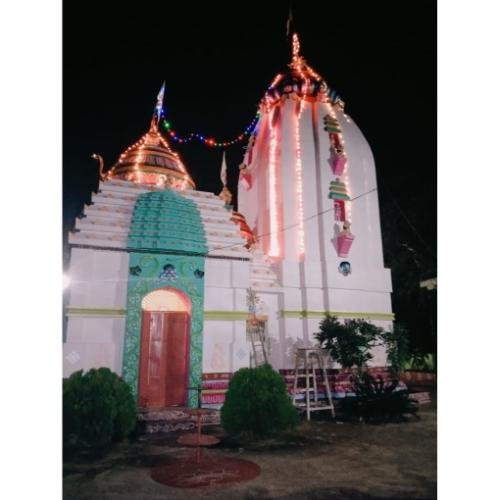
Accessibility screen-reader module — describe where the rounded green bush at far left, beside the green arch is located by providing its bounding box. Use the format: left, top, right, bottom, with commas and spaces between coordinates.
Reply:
63, 368, 136, 447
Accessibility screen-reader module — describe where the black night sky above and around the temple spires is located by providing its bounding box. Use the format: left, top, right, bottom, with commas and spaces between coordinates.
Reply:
63, 0, 436, 264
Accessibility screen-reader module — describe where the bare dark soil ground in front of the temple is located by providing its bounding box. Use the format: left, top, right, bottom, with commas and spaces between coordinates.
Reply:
63, 404, 436, 500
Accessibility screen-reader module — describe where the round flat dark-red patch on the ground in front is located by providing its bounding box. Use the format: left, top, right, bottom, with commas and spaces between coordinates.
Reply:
151, 454, 260, 488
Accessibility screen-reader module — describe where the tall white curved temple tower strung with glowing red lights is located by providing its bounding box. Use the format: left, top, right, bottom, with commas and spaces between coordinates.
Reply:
238, 35, 392, 366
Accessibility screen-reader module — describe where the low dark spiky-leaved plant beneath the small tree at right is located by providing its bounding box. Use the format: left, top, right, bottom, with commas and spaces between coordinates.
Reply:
341, 373, 418, 423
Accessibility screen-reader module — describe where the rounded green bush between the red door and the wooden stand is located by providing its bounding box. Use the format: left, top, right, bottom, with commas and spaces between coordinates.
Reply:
221, 365, 299, 439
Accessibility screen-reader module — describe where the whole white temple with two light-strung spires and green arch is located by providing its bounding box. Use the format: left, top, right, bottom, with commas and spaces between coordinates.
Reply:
64, 35, 393, 408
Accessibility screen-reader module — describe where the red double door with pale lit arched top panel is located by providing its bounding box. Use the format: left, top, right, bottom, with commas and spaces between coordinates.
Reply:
138, 288, 191, 408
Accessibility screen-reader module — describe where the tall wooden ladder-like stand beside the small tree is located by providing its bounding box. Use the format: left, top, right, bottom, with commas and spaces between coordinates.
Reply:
292, 347, 335, 420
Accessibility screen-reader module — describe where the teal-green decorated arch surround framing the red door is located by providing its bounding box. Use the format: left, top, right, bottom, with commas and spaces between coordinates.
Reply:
123, 189, 207, 407
